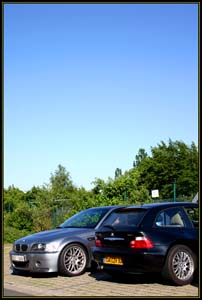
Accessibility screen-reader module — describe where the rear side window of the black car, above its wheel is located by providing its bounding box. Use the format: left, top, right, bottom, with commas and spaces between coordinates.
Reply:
155, 207, 186, 227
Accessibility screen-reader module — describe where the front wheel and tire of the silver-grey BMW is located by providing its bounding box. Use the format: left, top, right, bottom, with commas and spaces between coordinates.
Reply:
58, 243, 88, 276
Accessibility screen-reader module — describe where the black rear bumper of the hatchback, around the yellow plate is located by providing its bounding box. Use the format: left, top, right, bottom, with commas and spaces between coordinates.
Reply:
93, 248, 164, 274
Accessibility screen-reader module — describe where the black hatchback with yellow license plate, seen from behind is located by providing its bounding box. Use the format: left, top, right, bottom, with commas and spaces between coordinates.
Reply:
93, 202, 199, 285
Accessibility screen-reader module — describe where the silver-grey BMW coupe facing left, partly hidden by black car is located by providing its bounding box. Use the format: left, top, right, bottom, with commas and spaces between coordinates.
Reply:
9, 206, 125, 276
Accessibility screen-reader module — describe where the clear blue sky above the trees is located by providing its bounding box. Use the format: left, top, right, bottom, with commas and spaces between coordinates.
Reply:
3, 3, 199, 191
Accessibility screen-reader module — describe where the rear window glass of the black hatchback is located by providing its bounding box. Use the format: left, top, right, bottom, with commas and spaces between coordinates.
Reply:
102, 208, 147, 227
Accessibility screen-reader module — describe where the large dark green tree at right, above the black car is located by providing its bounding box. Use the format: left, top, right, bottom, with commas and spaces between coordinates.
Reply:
136, 140, 199, 199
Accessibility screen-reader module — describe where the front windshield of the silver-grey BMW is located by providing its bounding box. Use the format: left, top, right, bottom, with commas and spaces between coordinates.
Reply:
59, 207, 110, 228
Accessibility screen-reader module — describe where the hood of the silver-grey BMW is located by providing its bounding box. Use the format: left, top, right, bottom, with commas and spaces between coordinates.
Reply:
15, 228, 94, 243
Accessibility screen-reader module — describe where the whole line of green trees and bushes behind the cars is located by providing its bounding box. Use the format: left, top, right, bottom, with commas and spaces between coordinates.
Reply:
3, 139, 199, 242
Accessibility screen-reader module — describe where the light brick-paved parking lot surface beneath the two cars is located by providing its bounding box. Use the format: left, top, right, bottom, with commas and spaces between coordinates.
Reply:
3, 244, 200, 298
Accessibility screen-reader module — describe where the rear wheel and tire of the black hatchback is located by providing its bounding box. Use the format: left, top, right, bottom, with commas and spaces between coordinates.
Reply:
162, 245, 196, 285
